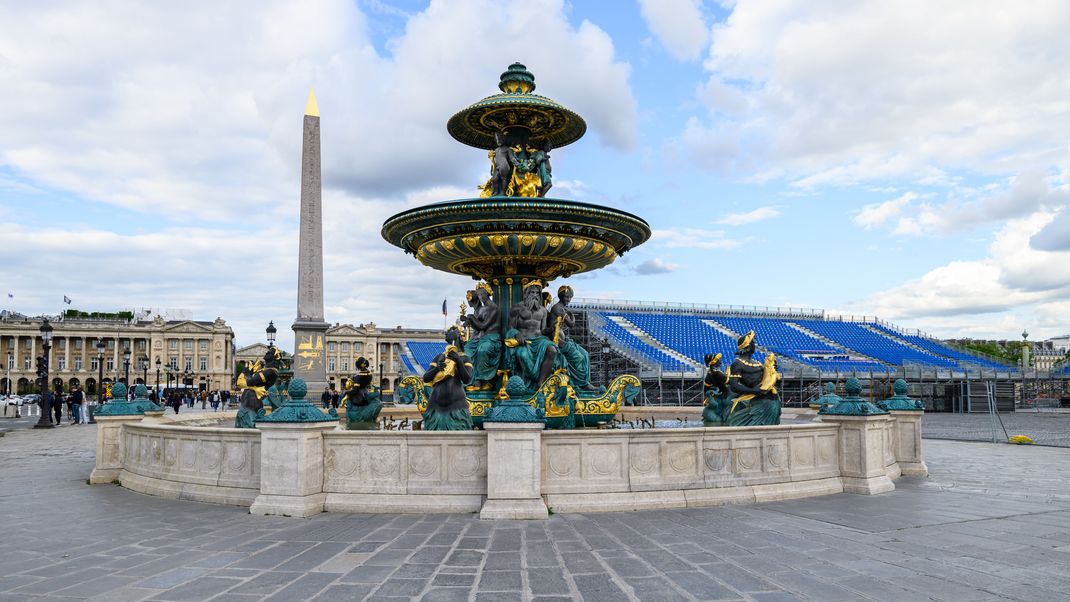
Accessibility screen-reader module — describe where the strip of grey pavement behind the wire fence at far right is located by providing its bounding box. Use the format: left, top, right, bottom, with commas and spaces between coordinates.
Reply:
921, 408, 1070, 447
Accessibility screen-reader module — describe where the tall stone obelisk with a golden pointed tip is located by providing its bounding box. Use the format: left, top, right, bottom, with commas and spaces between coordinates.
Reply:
293, 91, 328, 391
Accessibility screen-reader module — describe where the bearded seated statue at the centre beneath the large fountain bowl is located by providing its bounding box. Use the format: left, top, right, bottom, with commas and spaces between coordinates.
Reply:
505, 280, 557, 389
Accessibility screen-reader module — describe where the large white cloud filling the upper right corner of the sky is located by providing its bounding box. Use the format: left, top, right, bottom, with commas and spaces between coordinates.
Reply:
676, 0, 1070, 186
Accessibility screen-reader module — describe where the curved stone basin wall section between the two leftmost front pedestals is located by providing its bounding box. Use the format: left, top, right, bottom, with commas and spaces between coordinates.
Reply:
119, 422, 260, 506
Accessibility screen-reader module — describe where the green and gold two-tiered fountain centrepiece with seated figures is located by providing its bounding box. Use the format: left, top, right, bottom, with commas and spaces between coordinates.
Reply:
382, 63, 651, 428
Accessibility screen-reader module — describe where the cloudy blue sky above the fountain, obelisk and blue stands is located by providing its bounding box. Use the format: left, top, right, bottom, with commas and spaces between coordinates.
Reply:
0, 0, 1070, 348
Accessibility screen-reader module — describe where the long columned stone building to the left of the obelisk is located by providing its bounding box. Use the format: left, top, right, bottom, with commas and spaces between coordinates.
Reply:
0, 312, 234, 395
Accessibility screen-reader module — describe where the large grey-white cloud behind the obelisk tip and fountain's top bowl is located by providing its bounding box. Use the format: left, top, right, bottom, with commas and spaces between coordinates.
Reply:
0, 0, 637, 221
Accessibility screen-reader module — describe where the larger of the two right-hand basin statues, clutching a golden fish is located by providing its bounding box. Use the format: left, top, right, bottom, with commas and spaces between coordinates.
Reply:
725, 330, 780, 427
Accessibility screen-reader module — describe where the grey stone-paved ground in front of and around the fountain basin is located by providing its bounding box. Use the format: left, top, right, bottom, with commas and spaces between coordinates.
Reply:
0, 419, 1070, 602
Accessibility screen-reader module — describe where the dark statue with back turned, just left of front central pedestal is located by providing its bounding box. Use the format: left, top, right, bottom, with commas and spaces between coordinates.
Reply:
424, 326, 472, 431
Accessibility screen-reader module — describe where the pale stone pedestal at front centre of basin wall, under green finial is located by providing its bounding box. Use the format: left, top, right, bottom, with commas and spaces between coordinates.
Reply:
479, 422, 549, 520
